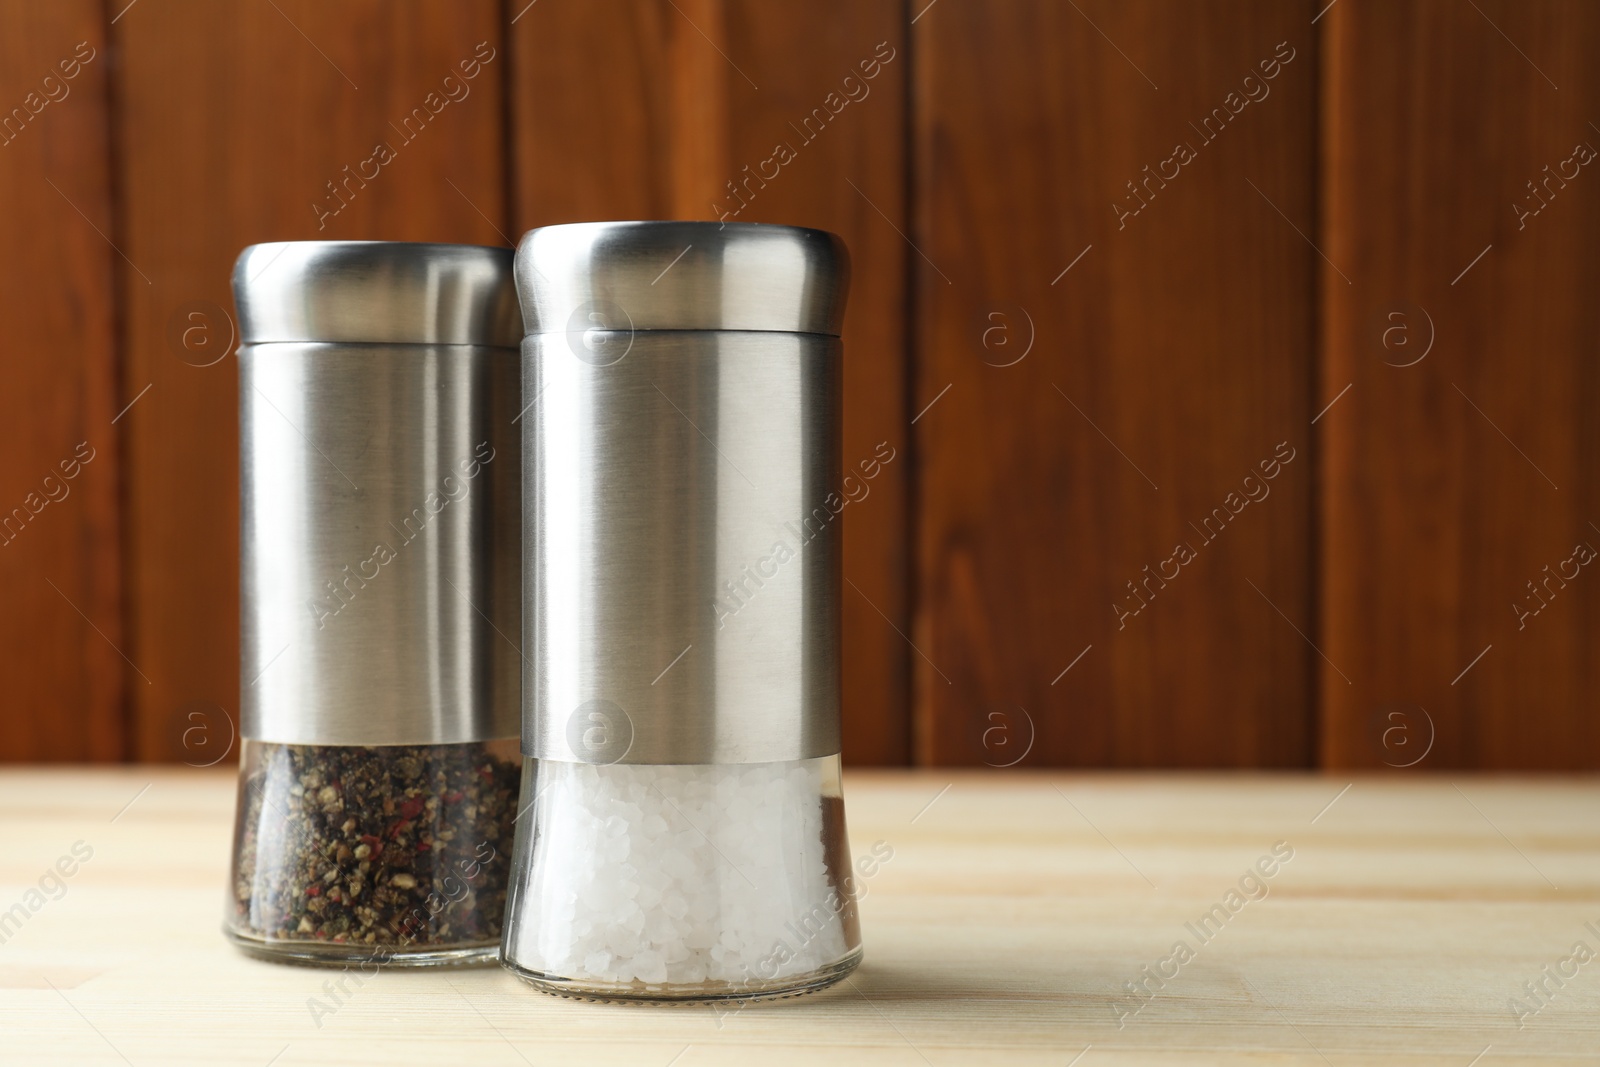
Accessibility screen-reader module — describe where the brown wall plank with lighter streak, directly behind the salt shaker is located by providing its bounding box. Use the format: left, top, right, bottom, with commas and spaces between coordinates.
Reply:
509, 0, 910, 763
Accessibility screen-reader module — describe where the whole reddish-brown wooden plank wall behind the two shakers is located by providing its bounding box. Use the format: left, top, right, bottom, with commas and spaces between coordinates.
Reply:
0, 0, 1600, 769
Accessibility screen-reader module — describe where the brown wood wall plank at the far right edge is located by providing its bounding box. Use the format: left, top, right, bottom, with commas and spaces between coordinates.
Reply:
1318, 0, 1600, 768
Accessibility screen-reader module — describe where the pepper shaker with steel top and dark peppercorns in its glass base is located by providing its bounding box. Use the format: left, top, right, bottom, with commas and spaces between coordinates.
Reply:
224, 242, 522, 968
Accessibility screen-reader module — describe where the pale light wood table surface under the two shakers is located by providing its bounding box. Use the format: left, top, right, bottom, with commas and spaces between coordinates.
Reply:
0, 768, 1600, 1067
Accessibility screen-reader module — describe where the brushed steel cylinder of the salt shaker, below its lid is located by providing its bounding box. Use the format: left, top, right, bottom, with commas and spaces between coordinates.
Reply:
523, 331, 842, 763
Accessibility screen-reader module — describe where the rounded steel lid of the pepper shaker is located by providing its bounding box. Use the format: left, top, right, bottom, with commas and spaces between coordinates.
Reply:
234, 242, 523, 347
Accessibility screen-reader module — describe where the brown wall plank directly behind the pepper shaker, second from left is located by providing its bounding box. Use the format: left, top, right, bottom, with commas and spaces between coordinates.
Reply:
114, 0, 507, 760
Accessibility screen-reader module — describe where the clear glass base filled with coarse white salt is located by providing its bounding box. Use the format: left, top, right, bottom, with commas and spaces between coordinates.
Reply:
501, 755, 861, 1000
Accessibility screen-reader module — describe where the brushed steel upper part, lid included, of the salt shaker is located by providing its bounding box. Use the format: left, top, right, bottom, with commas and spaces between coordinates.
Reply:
517, 222, 848, 765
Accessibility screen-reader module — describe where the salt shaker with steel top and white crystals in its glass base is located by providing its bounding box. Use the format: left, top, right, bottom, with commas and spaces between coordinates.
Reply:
501, 222, 861, 1000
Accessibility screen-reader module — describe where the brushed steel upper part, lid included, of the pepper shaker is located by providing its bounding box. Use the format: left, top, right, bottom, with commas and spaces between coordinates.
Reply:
235, 243, 522, 745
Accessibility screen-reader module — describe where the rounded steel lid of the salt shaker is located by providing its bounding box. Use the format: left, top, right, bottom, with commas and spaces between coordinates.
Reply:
517, 222, 850, 338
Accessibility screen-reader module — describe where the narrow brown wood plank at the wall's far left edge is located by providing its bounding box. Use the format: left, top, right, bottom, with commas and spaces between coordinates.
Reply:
0, 0, 126, 760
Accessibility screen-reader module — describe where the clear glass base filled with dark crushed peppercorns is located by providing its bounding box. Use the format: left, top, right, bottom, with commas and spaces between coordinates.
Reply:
222, 739, 522, 966
